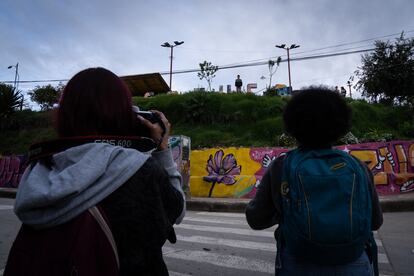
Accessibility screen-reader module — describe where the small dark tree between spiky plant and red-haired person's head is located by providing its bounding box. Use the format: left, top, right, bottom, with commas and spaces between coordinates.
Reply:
28, 84, 63, 110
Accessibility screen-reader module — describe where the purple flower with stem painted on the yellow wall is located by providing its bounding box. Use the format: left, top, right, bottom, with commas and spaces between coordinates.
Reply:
203, 150, 241, 197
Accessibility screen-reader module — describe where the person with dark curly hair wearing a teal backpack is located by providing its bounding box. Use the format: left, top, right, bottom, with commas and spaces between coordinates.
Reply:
246, 87, 383, 276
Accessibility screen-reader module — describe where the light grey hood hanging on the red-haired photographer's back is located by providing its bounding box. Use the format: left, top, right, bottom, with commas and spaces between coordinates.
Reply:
14, 143, 150, 228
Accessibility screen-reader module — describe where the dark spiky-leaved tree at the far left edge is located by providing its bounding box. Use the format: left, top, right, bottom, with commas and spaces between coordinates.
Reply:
0, 83, 23, 118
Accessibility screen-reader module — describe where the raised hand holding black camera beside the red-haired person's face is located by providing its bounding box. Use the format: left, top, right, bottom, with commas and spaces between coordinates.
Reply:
133, 106, 171, 150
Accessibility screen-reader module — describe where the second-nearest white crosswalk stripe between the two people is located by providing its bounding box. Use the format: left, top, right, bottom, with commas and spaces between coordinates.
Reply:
177, 235, 276, 252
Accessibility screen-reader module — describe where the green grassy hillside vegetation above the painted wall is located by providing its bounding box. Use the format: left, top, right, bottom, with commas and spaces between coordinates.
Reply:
0, 92, 414, 155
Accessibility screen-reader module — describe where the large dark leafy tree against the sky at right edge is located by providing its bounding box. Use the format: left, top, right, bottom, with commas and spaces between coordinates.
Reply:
356, 32, 414, 106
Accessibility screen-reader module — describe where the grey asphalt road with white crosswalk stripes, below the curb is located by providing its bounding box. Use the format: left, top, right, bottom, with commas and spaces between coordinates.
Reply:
0, 198, 414, 276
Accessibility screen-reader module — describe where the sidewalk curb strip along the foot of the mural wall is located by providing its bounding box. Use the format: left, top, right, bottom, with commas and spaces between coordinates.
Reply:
0, 188, 414, 213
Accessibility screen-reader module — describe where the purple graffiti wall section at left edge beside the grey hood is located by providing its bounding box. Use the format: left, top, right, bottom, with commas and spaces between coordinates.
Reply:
0, 155, 27, 188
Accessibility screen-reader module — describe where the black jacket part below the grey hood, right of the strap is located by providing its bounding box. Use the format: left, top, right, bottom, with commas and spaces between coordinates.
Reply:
101, 158, 184, 275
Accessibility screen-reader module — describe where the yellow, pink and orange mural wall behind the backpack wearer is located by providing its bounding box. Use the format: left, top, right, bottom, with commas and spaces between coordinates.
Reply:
190, 141, 414, 198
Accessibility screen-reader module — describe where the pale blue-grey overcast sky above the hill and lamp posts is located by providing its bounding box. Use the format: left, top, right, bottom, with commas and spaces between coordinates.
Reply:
0, 0, 414, 103
